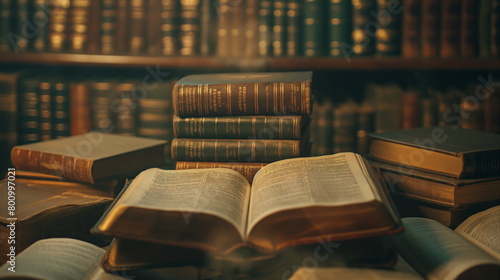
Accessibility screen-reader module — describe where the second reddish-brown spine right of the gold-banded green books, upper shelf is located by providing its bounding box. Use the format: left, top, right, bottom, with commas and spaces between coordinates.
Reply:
420, 0, 441, 57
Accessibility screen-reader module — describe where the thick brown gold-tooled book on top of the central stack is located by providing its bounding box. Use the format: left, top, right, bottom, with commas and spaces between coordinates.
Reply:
172, 72, 312, 117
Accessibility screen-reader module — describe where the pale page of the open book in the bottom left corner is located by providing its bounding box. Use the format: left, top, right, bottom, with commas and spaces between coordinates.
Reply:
0, 238, 124, 280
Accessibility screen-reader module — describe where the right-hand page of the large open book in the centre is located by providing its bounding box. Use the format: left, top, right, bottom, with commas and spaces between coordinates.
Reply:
247, 153, 375, 233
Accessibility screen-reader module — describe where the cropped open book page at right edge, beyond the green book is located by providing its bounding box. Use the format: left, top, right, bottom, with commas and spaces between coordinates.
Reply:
455, 205, 500, 260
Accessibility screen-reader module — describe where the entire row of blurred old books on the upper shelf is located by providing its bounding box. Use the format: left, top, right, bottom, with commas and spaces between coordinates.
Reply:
0, 0, 500, 58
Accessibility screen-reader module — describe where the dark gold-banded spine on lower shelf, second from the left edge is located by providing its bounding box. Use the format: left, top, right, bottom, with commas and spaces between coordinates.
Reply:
18, 78, 40, 144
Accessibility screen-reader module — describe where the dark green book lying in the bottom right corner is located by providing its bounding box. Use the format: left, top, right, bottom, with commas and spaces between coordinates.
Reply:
387, 218, 500, 280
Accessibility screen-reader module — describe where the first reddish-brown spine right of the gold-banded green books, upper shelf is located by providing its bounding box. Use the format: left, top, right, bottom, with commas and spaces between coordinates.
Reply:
401, 0, 422, 57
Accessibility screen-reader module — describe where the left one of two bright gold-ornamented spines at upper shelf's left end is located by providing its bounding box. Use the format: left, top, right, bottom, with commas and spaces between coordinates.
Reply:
48, 0, 70, 52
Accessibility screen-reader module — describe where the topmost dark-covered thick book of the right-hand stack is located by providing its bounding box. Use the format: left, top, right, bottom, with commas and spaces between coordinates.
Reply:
370, 126, 500, 178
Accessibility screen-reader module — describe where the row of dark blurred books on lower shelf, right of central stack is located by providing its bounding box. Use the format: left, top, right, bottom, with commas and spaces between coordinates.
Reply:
311, 83, 500, 155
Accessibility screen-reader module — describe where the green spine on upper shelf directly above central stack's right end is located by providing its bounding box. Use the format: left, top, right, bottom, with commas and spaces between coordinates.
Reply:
303, 0, 325, 56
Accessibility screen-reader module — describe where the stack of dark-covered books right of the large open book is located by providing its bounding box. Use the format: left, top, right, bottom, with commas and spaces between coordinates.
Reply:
369, 126, 500, 228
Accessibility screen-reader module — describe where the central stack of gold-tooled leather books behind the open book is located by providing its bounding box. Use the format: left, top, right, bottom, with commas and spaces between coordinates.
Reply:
172, 72, 312, 182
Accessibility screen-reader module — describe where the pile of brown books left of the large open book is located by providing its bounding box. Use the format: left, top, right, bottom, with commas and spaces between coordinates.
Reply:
0, 132, 166, 262
